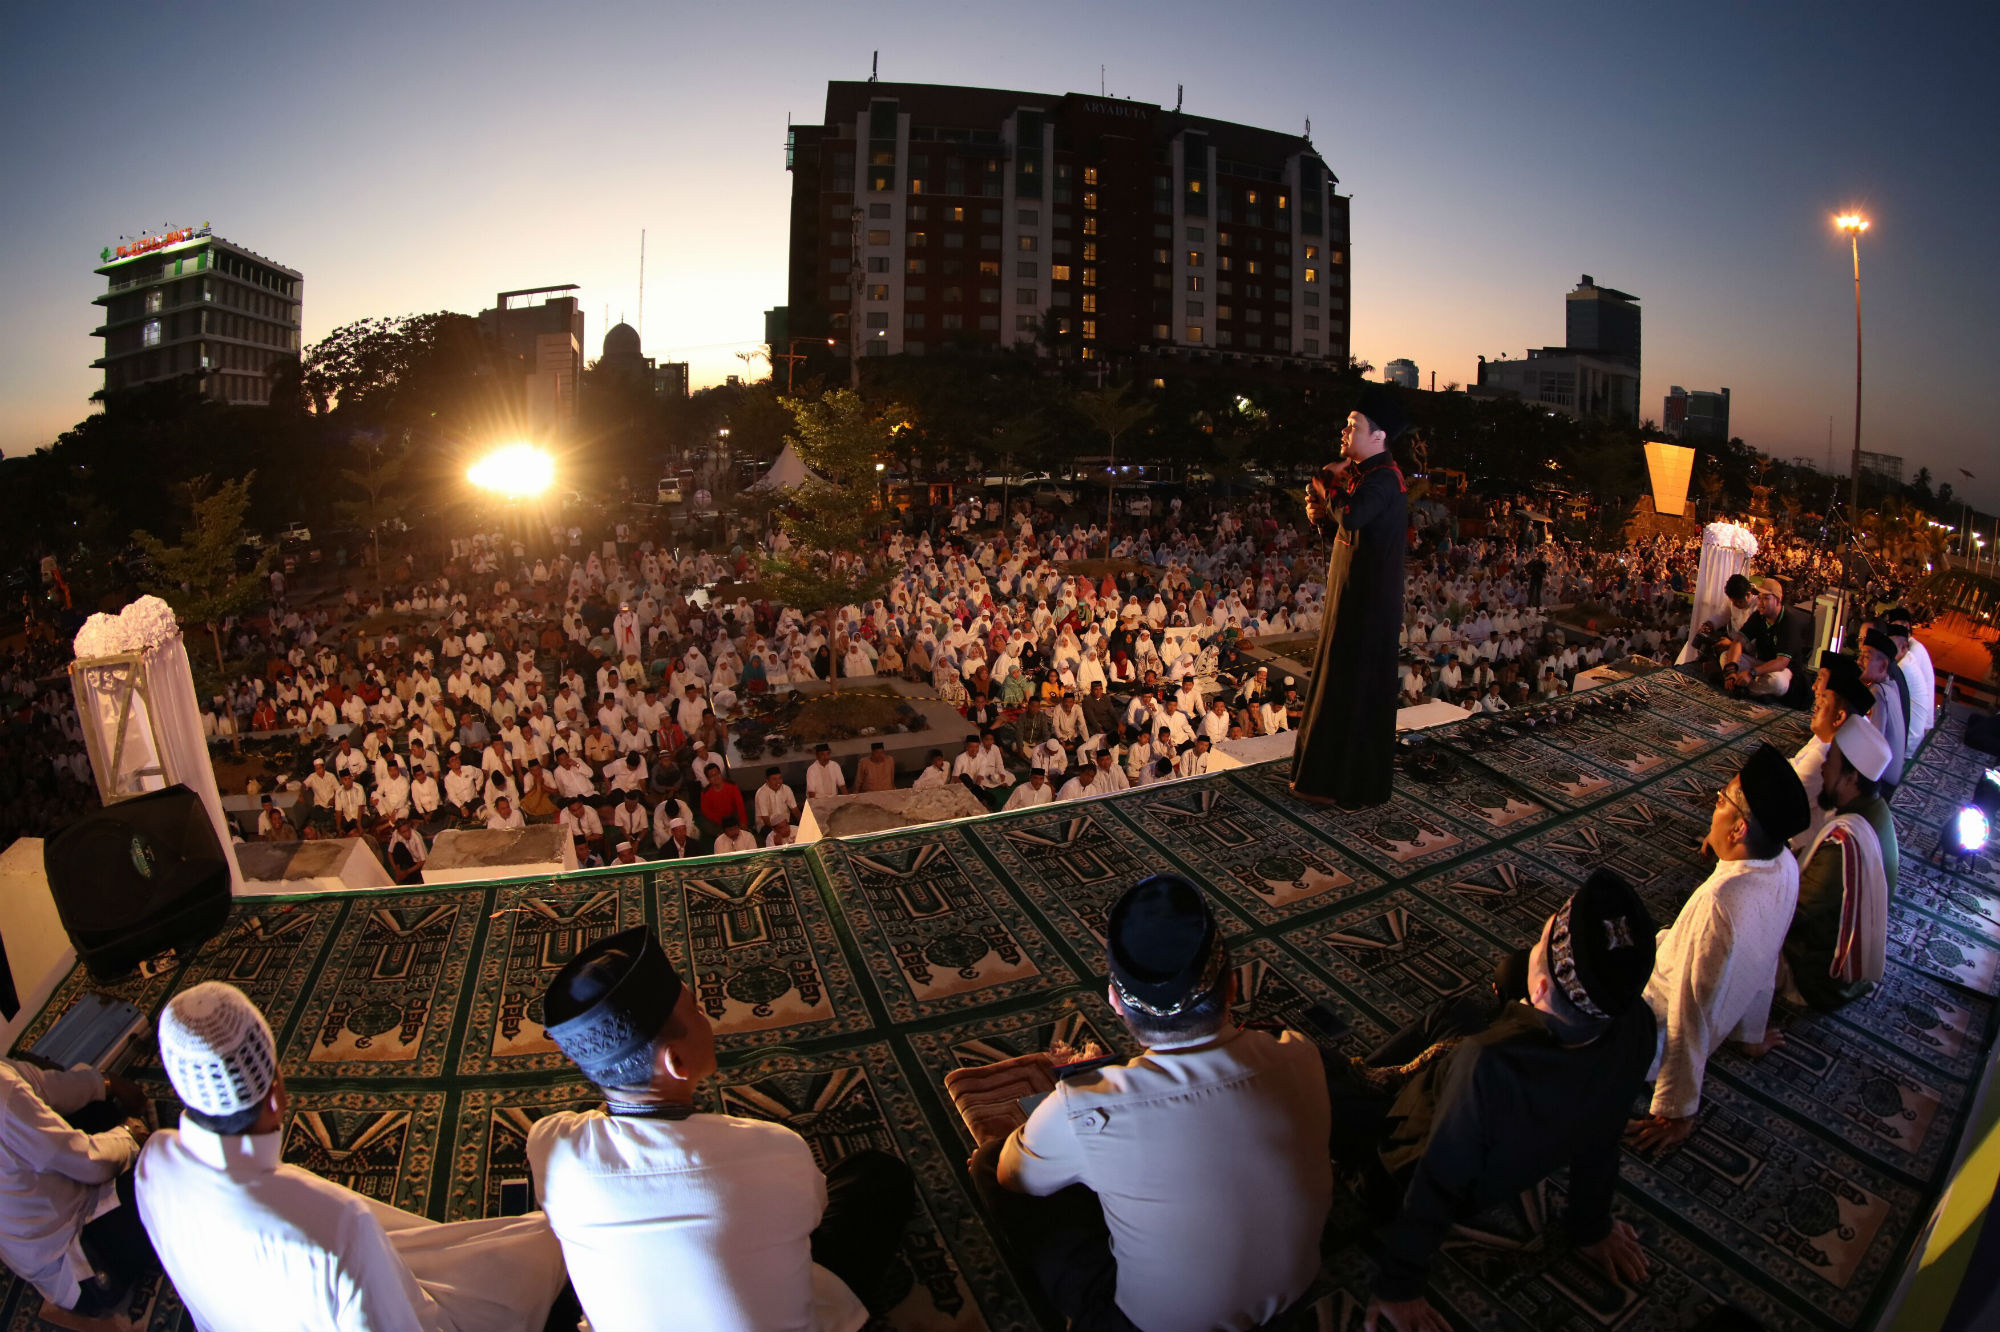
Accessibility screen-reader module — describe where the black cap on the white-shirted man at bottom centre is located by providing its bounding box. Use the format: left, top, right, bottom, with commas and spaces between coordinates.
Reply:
1104, 874, 1228, 1018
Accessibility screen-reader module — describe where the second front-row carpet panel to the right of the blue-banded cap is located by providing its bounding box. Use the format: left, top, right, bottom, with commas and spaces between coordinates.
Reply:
822, 828, 1080, 1022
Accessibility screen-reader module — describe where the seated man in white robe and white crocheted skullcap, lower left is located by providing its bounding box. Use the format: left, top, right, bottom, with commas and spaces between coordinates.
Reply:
138, 980, 574, 1332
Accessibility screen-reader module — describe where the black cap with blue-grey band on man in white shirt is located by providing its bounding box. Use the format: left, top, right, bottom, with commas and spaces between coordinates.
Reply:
542, 926, 680, 1086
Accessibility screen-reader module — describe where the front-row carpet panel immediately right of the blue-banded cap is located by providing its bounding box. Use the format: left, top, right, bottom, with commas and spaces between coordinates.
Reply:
654, 852, 874, 1052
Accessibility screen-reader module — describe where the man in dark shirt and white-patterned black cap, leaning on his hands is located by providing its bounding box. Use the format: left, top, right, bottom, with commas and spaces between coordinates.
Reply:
1328, 870, 1654, 1332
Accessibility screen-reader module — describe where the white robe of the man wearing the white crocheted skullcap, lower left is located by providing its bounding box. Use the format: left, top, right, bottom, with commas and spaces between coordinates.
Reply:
138, 1122, 562, 1332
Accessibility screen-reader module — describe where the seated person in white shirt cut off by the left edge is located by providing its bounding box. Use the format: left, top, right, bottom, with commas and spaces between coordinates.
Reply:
0, 1060, 158, 1318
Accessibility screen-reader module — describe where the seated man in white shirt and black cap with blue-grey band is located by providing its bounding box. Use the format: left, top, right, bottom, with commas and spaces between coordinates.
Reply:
528, 926, 916, 1332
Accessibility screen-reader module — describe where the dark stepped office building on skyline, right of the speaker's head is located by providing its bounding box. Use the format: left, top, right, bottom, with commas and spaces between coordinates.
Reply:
1470, 274, 1640, 426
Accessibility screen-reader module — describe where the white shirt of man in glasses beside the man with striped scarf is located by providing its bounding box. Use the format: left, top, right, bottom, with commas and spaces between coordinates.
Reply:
1646, 850, 1798, 1118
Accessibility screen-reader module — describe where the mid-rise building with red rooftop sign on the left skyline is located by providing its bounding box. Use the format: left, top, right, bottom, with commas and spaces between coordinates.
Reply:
90, 224, 304, 406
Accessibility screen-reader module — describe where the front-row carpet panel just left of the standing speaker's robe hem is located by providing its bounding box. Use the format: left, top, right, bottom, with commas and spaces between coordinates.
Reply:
1092, 782, 1384, 924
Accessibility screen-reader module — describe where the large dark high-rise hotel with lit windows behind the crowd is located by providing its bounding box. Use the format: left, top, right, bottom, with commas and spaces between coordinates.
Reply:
788, 82, 1348, 370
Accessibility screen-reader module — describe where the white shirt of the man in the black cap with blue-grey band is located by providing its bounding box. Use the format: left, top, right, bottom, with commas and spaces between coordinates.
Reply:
528, 1110, 868, 1332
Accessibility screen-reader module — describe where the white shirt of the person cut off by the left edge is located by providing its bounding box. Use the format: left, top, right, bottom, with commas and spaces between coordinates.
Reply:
0, 1060, 138, 1308
